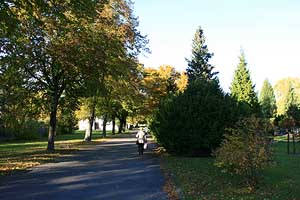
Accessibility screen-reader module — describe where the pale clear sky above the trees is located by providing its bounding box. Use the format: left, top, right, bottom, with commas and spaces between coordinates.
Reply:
134, 0, 300, 91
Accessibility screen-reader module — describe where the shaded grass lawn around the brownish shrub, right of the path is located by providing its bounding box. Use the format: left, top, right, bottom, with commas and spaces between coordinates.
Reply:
162, 137, 300, 200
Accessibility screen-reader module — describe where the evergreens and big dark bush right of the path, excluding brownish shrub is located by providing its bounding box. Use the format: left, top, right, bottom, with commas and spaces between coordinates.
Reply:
151, 27, 300, 155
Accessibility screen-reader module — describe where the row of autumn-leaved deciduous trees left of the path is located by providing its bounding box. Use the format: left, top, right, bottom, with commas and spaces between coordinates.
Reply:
0, 0, 148, 150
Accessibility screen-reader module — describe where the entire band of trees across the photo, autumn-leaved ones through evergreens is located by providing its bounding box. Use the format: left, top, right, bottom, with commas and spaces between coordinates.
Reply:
0, 0, 300, 157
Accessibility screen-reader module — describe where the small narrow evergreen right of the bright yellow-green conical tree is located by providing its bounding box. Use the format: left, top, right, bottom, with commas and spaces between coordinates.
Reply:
259, 79, 276, 118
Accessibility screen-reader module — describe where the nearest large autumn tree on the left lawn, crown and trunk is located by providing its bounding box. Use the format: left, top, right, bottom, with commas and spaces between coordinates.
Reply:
0, 0, 147, 150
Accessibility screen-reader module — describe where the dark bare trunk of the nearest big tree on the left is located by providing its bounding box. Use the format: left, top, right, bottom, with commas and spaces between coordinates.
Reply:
47, 92, 58, 151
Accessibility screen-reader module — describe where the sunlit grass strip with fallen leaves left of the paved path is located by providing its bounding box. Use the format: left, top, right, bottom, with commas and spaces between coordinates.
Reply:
0, 131, 122, 176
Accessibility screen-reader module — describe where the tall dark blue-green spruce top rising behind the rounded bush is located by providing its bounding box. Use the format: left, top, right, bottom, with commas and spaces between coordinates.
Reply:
187, 27, 218, 83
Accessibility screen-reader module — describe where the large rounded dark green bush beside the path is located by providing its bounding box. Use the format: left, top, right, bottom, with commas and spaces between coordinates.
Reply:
150, 80, 236, 156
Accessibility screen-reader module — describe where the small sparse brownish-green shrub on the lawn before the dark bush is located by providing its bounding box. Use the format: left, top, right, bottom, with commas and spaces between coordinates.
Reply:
215, 117, 272, 189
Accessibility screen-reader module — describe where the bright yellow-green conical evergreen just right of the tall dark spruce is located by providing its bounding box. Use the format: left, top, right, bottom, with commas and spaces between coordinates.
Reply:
230, 50, 259, 116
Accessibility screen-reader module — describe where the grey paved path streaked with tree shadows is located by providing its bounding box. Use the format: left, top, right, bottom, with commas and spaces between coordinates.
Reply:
0, 135, 167, 200
